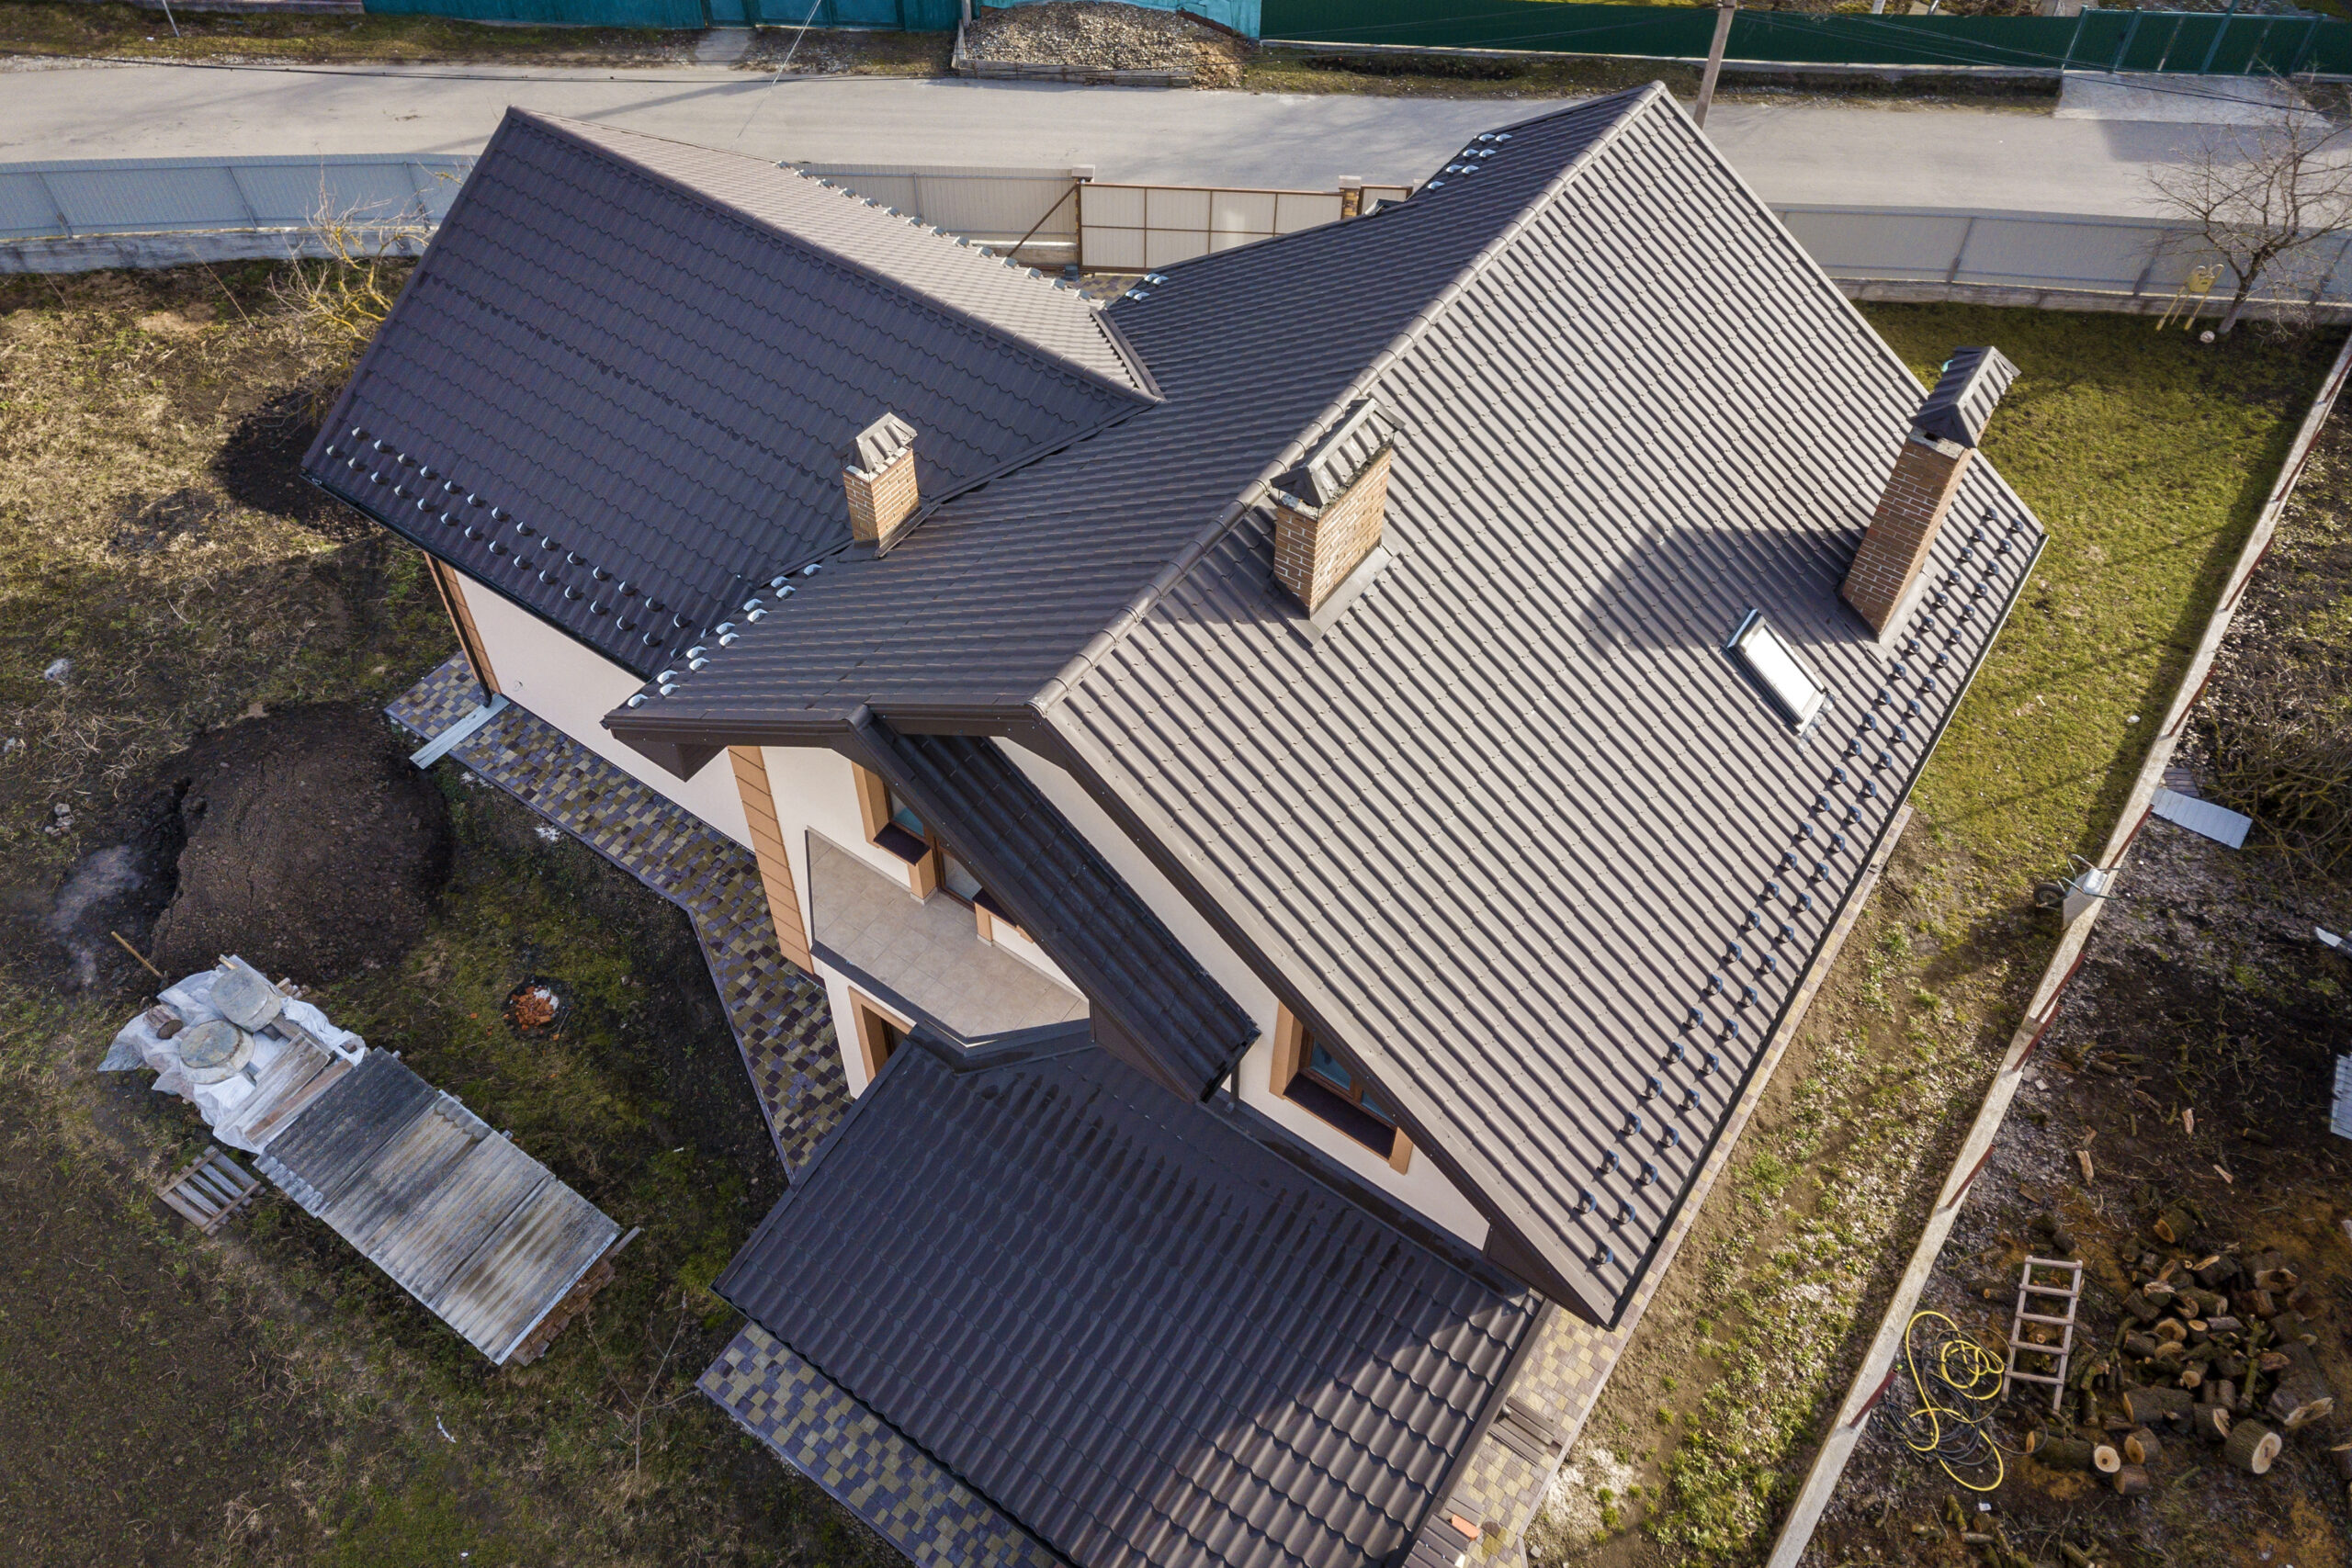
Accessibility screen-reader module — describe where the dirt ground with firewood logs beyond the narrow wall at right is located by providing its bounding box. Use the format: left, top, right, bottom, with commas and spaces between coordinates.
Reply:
1809, 401, 2352, 1568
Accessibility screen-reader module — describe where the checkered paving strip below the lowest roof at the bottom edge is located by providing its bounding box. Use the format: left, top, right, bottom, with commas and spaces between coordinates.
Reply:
696, 1324, 1061, 1568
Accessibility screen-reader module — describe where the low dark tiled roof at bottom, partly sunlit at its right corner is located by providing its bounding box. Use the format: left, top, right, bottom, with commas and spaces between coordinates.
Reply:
718, 1043, 1538, 1568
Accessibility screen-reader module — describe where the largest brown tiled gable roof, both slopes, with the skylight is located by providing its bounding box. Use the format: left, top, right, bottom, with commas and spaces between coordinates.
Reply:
606, 87, 2041, 1321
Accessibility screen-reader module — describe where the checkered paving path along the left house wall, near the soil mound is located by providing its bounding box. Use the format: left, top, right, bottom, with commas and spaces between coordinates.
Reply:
386, 656, 849, 1178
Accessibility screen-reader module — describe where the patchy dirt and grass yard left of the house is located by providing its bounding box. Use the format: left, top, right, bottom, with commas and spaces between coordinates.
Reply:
0, 265, 891, 1568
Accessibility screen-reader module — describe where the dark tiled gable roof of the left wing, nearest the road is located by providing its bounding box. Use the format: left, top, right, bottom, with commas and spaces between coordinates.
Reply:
303, 110, 1152, 674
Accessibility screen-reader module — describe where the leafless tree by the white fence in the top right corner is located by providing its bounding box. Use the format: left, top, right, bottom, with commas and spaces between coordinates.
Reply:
2147, 110, 2352, 332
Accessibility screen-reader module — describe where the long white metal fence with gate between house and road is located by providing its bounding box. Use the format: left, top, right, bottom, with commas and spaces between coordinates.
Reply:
0, 155, 2352, 310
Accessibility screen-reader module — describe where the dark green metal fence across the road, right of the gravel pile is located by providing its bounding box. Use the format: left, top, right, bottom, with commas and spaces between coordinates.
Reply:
1263, 0, 2352, 75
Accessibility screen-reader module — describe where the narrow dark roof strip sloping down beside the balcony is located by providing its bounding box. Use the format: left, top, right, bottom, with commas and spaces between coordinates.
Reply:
864, 722, 1259, 1100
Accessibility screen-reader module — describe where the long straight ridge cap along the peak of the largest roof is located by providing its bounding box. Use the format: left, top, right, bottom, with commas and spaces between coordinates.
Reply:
1030, 83, 1672, 712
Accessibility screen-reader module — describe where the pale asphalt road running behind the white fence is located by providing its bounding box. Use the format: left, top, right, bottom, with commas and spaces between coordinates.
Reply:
0, 63, 2197, 214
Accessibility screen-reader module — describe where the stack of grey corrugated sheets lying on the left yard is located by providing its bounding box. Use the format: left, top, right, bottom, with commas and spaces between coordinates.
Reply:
261, 1051, 621, 1366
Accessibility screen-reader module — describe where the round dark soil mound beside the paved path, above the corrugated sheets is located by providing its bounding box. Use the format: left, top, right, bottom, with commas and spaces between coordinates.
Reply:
151, 703, 449, 985
